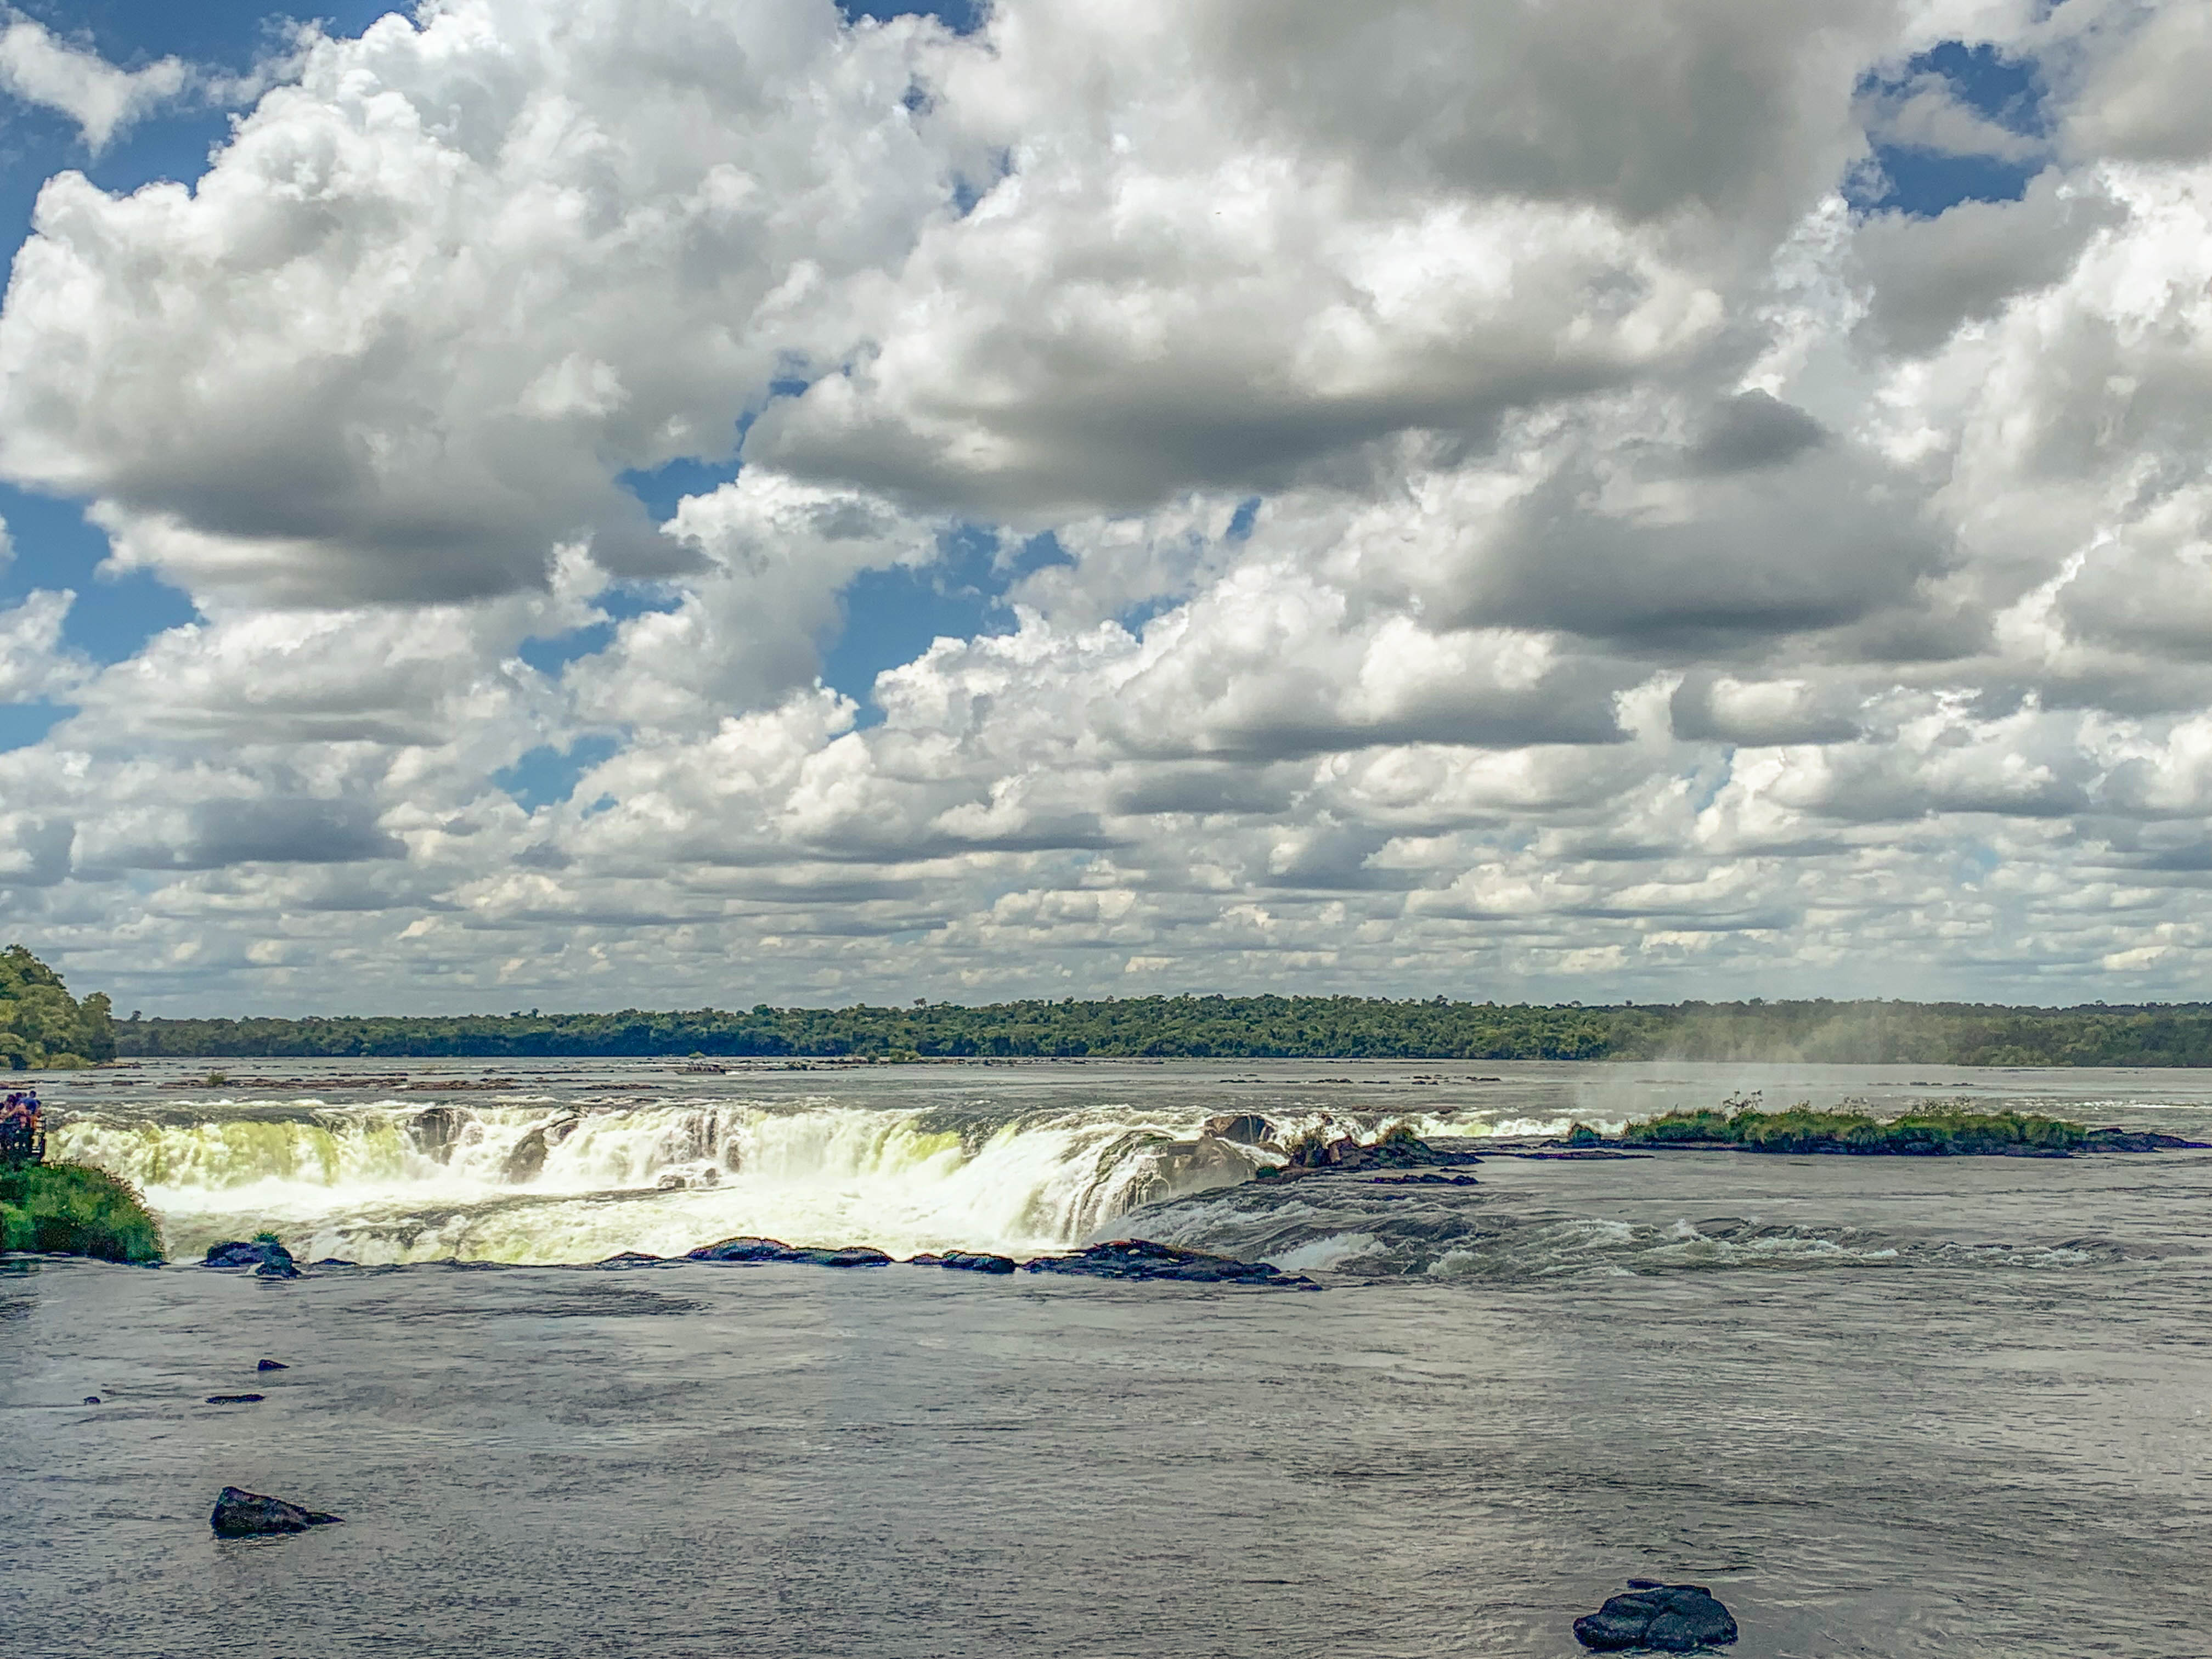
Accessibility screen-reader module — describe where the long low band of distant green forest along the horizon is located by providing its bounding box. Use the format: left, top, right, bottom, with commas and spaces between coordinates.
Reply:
115, 995, 2212, 1066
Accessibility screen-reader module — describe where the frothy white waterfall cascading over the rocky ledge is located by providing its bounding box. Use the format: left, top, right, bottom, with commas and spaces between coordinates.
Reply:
58, 1097, 1424, 1263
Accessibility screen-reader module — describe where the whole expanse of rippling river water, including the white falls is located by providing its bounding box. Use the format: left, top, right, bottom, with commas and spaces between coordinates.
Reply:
13, 1062, 2212, 1659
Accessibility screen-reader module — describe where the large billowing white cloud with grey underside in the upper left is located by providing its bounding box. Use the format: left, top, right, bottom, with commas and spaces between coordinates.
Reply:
0, 0, 978, 606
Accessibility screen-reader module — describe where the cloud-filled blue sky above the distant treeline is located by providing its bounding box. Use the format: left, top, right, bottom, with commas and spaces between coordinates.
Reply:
0, 0, 2212, 1013
